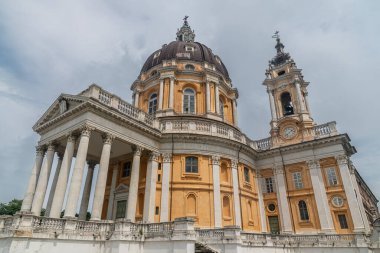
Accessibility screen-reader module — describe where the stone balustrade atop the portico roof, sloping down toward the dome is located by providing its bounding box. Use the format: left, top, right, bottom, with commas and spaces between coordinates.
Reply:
79, 84, 159, 129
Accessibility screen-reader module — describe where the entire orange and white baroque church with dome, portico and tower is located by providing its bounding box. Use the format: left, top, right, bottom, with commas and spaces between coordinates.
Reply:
0, 18, 380, 253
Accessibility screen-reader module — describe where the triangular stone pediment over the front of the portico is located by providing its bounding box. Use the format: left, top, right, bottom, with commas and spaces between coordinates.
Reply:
33, 94, 87, 130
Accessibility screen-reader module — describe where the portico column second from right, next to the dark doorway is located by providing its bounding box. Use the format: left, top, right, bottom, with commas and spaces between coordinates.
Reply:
126, 146, 142, 222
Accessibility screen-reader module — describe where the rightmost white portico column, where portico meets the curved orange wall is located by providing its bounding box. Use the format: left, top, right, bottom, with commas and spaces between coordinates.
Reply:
143, 152, 158, 223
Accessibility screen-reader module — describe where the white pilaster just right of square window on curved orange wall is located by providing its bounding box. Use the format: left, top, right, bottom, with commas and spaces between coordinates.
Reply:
211, 156, 222, 228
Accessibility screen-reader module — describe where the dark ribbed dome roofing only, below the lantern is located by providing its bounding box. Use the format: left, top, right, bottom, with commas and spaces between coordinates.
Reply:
141, 40, 230, 79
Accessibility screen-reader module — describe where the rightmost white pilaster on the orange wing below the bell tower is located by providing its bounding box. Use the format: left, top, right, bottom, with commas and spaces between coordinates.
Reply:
336, 155, 365, 232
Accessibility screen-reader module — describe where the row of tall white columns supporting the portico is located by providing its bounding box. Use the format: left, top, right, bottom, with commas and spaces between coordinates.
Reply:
21, 126, 158, 222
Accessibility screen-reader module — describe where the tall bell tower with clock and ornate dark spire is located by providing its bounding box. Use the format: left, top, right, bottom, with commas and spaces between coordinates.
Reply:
263, 31, 314, 146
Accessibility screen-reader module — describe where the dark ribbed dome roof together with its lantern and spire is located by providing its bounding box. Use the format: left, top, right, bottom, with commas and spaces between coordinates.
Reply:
141, 20, 230, 79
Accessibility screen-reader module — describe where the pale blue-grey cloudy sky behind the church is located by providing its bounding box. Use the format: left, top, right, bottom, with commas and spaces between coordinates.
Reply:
0, 0, 380, 209
